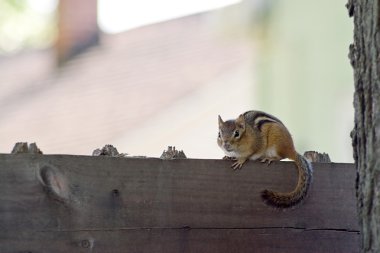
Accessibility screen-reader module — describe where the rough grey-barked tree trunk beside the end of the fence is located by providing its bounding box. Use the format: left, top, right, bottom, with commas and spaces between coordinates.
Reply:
347, 0, 380, 252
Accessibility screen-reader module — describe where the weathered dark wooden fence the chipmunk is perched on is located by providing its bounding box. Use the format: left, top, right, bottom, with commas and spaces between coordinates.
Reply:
0, 154, 359, 253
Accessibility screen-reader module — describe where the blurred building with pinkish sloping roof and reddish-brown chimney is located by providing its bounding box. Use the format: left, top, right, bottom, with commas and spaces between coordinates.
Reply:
0, 0, 253, 157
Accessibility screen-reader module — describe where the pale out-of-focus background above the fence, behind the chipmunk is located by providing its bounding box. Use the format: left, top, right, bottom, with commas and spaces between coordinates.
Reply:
0, 0, 354, 162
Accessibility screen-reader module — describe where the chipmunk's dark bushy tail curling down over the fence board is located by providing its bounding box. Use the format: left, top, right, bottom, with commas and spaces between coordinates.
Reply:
261, 153, 313, 208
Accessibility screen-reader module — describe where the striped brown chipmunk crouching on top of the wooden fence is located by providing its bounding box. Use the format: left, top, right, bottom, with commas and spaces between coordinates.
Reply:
217, 111, 312, 208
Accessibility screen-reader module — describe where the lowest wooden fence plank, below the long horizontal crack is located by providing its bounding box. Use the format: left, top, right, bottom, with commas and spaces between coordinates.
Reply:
0, 228, 359, 253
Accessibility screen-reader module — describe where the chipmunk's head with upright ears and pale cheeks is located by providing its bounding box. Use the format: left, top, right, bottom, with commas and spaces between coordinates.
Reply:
217, 115, 246, 157
